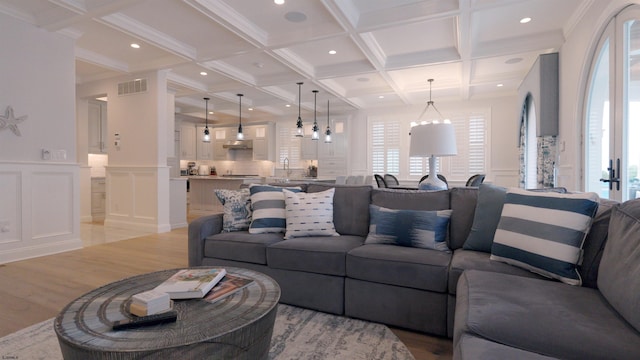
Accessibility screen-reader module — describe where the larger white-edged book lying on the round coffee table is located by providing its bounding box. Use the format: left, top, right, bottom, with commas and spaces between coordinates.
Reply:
155, 268, 227, 299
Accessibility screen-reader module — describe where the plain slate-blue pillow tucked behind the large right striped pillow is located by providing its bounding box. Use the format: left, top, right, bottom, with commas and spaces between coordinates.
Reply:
462, 184, 507, 253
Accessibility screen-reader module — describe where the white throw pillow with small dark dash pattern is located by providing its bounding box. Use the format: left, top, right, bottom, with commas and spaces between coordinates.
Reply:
283, 188, 340, 239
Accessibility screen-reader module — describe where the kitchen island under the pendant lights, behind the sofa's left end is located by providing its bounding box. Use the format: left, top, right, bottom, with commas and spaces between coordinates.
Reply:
189, 175, 265, 216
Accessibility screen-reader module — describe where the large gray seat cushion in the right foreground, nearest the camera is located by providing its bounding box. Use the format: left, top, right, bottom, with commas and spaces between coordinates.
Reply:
453, 270, 640, 359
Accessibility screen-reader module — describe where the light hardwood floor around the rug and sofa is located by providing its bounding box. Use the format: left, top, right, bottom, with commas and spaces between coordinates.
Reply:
0, 224, 452, 360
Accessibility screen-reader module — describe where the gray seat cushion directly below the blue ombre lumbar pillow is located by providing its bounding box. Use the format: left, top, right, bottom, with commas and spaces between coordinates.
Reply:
347, 244, 451, 292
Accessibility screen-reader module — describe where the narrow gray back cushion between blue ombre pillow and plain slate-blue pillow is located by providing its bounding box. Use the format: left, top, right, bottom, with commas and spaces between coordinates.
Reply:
449, 187, 478, 250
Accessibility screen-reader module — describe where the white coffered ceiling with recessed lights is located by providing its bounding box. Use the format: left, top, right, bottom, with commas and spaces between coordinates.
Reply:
0, 0, 594, 122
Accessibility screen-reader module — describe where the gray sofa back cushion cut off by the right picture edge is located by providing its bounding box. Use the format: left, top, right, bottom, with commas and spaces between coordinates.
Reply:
598, 199, 640, 331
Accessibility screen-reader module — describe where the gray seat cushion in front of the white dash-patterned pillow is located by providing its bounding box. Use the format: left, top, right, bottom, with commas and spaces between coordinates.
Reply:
267, 235, 364, 276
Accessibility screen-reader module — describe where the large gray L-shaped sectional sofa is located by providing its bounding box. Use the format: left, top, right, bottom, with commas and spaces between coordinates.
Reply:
189, 184, 640, 359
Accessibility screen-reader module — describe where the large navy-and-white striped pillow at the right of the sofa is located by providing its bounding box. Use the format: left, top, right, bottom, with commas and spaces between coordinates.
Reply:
491, 189, 598, 285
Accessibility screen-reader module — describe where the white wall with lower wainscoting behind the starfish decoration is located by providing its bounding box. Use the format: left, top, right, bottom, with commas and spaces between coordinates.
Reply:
0, 14, 81, 263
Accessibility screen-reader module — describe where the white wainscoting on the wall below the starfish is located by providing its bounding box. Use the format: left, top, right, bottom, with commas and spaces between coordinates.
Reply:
0, 162, 82, 263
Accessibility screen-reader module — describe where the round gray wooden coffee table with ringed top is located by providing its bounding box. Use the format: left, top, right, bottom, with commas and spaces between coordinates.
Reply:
54, 267, 280, 360
